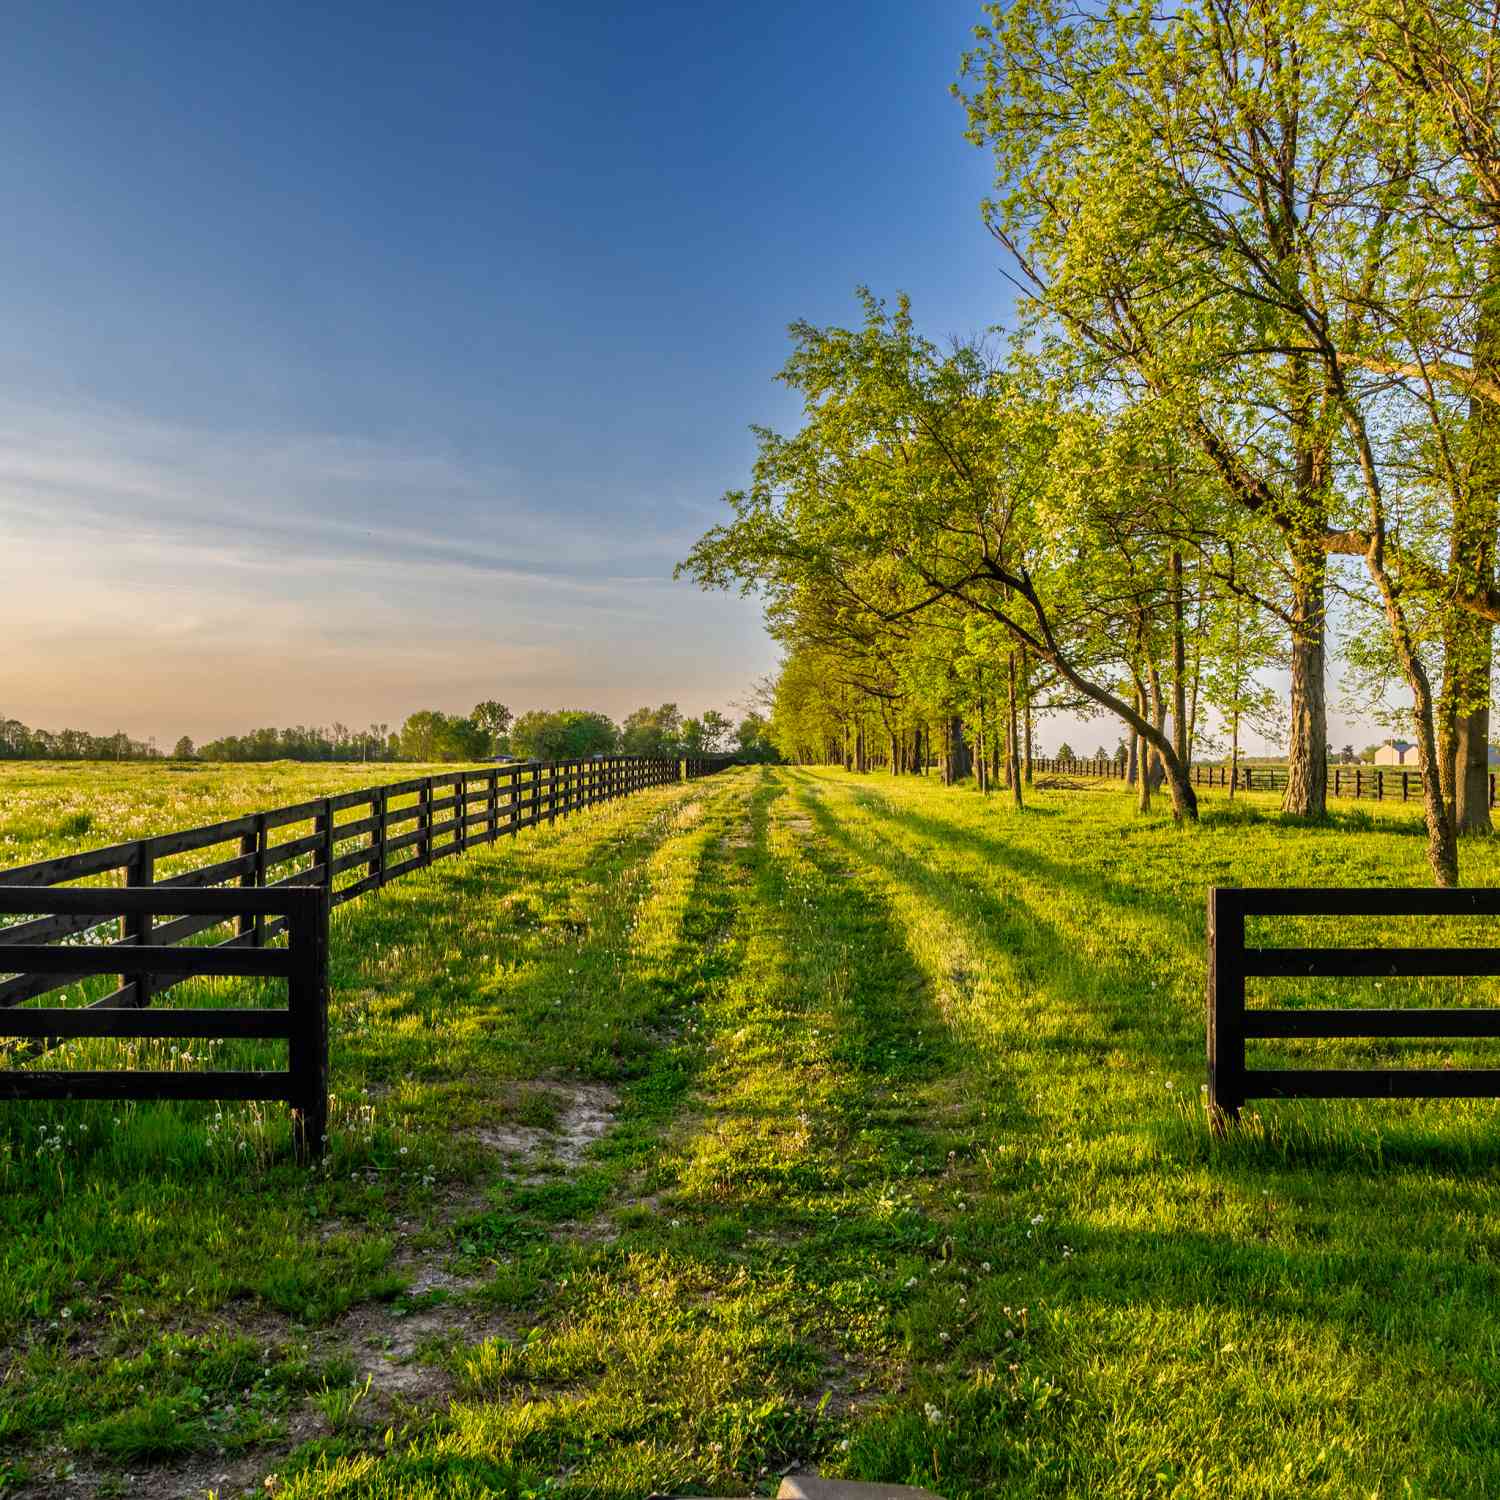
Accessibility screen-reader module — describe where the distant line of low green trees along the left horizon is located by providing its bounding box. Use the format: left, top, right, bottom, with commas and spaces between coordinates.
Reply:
0, 699, 777, 762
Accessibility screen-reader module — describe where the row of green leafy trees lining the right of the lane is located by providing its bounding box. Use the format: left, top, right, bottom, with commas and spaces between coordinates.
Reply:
683, 0, 1500, 885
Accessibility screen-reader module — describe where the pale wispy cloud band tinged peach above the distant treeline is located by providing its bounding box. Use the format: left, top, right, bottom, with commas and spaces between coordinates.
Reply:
0, 402, 765, 735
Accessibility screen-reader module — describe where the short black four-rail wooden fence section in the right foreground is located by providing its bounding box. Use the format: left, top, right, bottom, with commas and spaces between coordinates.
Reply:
1208, 888, 1500, 1124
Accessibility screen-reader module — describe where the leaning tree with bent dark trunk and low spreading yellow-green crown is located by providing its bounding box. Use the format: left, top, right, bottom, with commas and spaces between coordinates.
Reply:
680, 293, 1197, 819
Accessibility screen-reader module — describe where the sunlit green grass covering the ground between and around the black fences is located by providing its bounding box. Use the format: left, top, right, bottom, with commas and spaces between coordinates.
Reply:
0, 768, 1500, 1500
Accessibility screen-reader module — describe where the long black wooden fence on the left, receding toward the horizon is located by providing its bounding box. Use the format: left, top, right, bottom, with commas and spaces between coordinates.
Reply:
0, 756, 729, 1155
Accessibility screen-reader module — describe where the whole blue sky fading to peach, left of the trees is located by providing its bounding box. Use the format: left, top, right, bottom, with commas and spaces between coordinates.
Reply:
0, 0, 1011, 740
